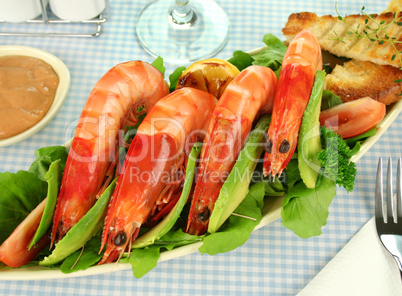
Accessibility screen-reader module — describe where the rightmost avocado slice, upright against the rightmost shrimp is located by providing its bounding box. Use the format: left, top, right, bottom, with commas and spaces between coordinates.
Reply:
297, 71, 325, 189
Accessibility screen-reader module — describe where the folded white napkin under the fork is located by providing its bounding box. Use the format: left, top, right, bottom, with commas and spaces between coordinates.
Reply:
297, 218, 402, 296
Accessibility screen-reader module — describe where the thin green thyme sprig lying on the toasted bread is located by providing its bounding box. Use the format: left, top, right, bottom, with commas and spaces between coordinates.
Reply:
334, 4, 402, 70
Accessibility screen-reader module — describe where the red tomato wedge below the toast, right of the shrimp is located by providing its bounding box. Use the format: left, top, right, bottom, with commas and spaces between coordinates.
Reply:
320, 97, 385, 139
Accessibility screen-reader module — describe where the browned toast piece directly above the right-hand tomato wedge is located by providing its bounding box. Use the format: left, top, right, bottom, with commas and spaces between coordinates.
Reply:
324, 59, 402, 105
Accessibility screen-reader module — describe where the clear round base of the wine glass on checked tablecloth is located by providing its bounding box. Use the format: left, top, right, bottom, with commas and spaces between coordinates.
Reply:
136, 0, 229, 64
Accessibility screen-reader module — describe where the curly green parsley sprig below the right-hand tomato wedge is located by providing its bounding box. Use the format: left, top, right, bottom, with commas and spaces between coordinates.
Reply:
317, 127, 357, 192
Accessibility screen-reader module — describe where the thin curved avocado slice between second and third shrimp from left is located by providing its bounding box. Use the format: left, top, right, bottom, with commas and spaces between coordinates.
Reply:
131, 143, 202, 249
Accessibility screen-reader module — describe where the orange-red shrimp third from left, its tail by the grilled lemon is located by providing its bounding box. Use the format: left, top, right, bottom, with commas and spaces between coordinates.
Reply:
186, 66, 277, 235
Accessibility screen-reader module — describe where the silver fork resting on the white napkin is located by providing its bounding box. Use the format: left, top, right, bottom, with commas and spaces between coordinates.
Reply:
375, 157, 402, 277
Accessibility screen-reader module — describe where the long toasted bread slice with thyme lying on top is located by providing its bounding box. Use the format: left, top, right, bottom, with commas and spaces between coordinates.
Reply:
282, 12, 402, 67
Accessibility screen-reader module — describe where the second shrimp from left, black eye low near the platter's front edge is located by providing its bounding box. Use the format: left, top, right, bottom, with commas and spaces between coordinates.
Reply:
99, 88, 216, 264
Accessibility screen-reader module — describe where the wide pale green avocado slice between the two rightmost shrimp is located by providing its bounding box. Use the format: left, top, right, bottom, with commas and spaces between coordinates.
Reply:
208, 115, 271, 233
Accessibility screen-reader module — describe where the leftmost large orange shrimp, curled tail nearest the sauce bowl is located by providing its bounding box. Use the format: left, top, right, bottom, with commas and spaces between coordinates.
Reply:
51, 61, 169, 245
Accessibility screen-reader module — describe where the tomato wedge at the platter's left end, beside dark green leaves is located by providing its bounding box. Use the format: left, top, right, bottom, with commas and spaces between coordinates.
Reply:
0, 199, 50, 267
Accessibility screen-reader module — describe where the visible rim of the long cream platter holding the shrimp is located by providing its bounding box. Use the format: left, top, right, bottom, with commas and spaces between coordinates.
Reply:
0, 48, 402, 280
